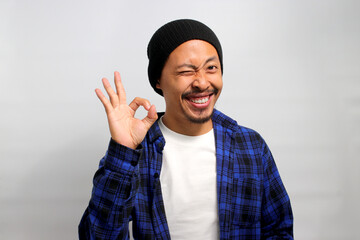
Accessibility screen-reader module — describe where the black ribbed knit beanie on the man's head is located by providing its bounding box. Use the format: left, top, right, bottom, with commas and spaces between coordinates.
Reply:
147, 19, 223, 95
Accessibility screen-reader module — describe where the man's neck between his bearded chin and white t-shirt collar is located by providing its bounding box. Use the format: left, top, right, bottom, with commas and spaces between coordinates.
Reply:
162, 112, 213, 136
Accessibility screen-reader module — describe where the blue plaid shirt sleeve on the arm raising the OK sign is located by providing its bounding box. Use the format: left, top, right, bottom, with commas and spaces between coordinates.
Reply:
79, 139, 141, 240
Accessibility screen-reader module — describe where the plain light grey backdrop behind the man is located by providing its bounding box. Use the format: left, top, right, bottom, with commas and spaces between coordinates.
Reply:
0, 0, 360, 240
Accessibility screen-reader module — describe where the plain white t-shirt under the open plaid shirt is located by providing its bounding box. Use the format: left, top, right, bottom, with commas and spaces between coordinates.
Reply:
159, 119, 220, 240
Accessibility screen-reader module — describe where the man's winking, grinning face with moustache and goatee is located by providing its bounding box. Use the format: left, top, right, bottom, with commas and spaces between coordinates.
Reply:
157, 40, 222, 127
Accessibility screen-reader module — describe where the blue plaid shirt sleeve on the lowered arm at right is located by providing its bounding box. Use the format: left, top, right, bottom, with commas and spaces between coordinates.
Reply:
261, 140, 293, 240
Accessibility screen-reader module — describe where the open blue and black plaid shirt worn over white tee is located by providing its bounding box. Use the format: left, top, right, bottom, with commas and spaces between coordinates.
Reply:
79, 110, 293, 240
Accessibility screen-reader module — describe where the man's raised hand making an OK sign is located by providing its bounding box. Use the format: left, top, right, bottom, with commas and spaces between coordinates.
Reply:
95, 72, 158, 149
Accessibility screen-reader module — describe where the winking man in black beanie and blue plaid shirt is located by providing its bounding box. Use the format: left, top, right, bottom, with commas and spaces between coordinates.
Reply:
79, 20, 293, 240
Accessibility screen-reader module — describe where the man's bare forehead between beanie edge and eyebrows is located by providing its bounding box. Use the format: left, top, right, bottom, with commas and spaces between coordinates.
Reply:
168, 39, 219, 62
